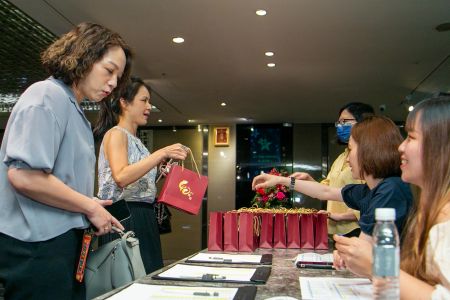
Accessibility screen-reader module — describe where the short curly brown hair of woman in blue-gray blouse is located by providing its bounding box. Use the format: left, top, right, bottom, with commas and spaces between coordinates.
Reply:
41, 22, 132, 94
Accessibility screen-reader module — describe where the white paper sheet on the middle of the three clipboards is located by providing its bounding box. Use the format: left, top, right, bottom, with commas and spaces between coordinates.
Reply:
158, 264, 256, 282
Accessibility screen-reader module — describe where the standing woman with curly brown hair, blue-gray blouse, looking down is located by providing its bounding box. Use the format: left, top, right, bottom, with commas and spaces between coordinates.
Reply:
0, 23, 131, 299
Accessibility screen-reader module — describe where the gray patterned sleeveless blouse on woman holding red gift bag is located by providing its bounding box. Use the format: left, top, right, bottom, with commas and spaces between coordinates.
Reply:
97, 126, 156, 203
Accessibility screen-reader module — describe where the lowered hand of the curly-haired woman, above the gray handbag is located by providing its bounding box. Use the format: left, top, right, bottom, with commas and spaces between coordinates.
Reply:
86, 197, 125, 236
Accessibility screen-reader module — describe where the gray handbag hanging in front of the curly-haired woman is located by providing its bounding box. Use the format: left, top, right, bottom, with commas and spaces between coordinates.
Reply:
84, 231, 146, 299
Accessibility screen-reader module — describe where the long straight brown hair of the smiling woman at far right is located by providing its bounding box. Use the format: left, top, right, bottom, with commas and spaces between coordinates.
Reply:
401, 97, 450, 285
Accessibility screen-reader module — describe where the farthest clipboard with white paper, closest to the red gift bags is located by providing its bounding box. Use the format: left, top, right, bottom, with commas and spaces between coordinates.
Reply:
185, 252, 273, 265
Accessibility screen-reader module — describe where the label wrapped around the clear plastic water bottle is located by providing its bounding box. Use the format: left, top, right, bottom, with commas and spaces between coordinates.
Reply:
373, 246, 400, 277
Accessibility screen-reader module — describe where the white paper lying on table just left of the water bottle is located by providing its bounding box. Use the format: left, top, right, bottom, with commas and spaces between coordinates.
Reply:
299, 277, 372, 300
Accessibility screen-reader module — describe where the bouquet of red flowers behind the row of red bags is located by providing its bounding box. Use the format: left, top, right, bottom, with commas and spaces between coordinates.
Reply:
252, 168, 291, 208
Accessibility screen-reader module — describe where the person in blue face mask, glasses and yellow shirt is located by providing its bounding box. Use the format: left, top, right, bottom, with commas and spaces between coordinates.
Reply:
321, 102, 374, 237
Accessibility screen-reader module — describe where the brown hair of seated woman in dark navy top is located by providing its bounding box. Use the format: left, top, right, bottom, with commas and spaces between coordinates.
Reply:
351, 116, 403, 179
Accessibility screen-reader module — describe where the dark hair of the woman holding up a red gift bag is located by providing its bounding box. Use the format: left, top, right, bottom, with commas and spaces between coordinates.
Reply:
94, 76, 151, 141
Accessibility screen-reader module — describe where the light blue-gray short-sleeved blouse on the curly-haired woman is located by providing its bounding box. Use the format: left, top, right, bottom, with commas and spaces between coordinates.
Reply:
0, 77, 95, 242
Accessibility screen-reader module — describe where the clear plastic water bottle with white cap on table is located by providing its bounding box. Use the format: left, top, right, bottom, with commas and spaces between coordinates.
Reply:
372, 208, 400, 300
